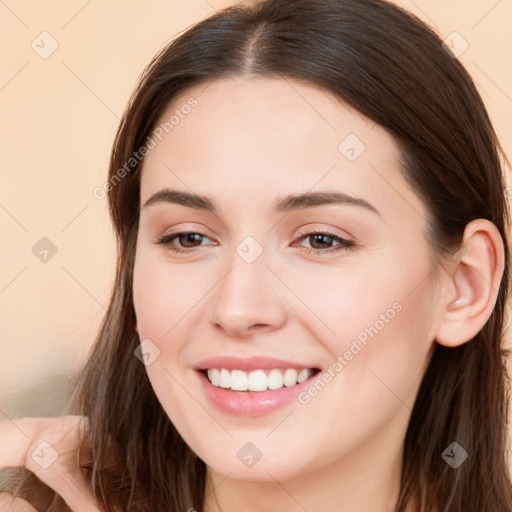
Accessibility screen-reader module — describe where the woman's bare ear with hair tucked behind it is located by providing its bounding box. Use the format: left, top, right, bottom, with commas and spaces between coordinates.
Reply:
435, 219, 505, 347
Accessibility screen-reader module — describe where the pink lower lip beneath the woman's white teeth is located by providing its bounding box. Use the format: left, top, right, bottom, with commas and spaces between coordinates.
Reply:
196, 372, 317, 416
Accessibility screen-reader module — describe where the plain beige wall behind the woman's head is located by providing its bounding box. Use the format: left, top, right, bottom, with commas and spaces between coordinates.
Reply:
0, 0, 512, 452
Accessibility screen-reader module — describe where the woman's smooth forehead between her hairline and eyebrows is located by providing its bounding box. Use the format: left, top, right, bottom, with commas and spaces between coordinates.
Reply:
141, 77, 423, 222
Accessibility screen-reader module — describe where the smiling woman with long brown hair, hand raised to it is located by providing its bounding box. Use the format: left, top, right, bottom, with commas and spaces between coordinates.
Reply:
3, 0, 512, 512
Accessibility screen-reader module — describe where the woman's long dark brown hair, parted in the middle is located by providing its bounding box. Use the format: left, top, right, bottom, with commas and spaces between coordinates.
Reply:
4, 0, 512, 512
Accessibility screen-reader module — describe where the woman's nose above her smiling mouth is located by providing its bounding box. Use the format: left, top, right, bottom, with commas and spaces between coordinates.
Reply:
211, 251, 287, 339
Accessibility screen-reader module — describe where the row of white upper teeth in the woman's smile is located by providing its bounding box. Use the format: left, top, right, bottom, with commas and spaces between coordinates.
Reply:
207, 368, 313, 391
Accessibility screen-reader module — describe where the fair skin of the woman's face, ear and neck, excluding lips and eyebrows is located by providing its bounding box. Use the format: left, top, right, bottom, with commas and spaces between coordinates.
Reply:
133, 77, 503, 512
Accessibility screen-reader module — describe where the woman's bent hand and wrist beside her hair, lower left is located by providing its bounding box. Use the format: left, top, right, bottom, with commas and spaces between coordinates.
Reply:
0, 415, 101, 512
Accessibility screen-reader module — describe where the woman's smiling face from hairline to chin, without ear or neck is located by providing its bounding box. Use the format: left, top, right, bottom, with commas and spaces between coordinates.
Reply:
133, 78, 439, 481
